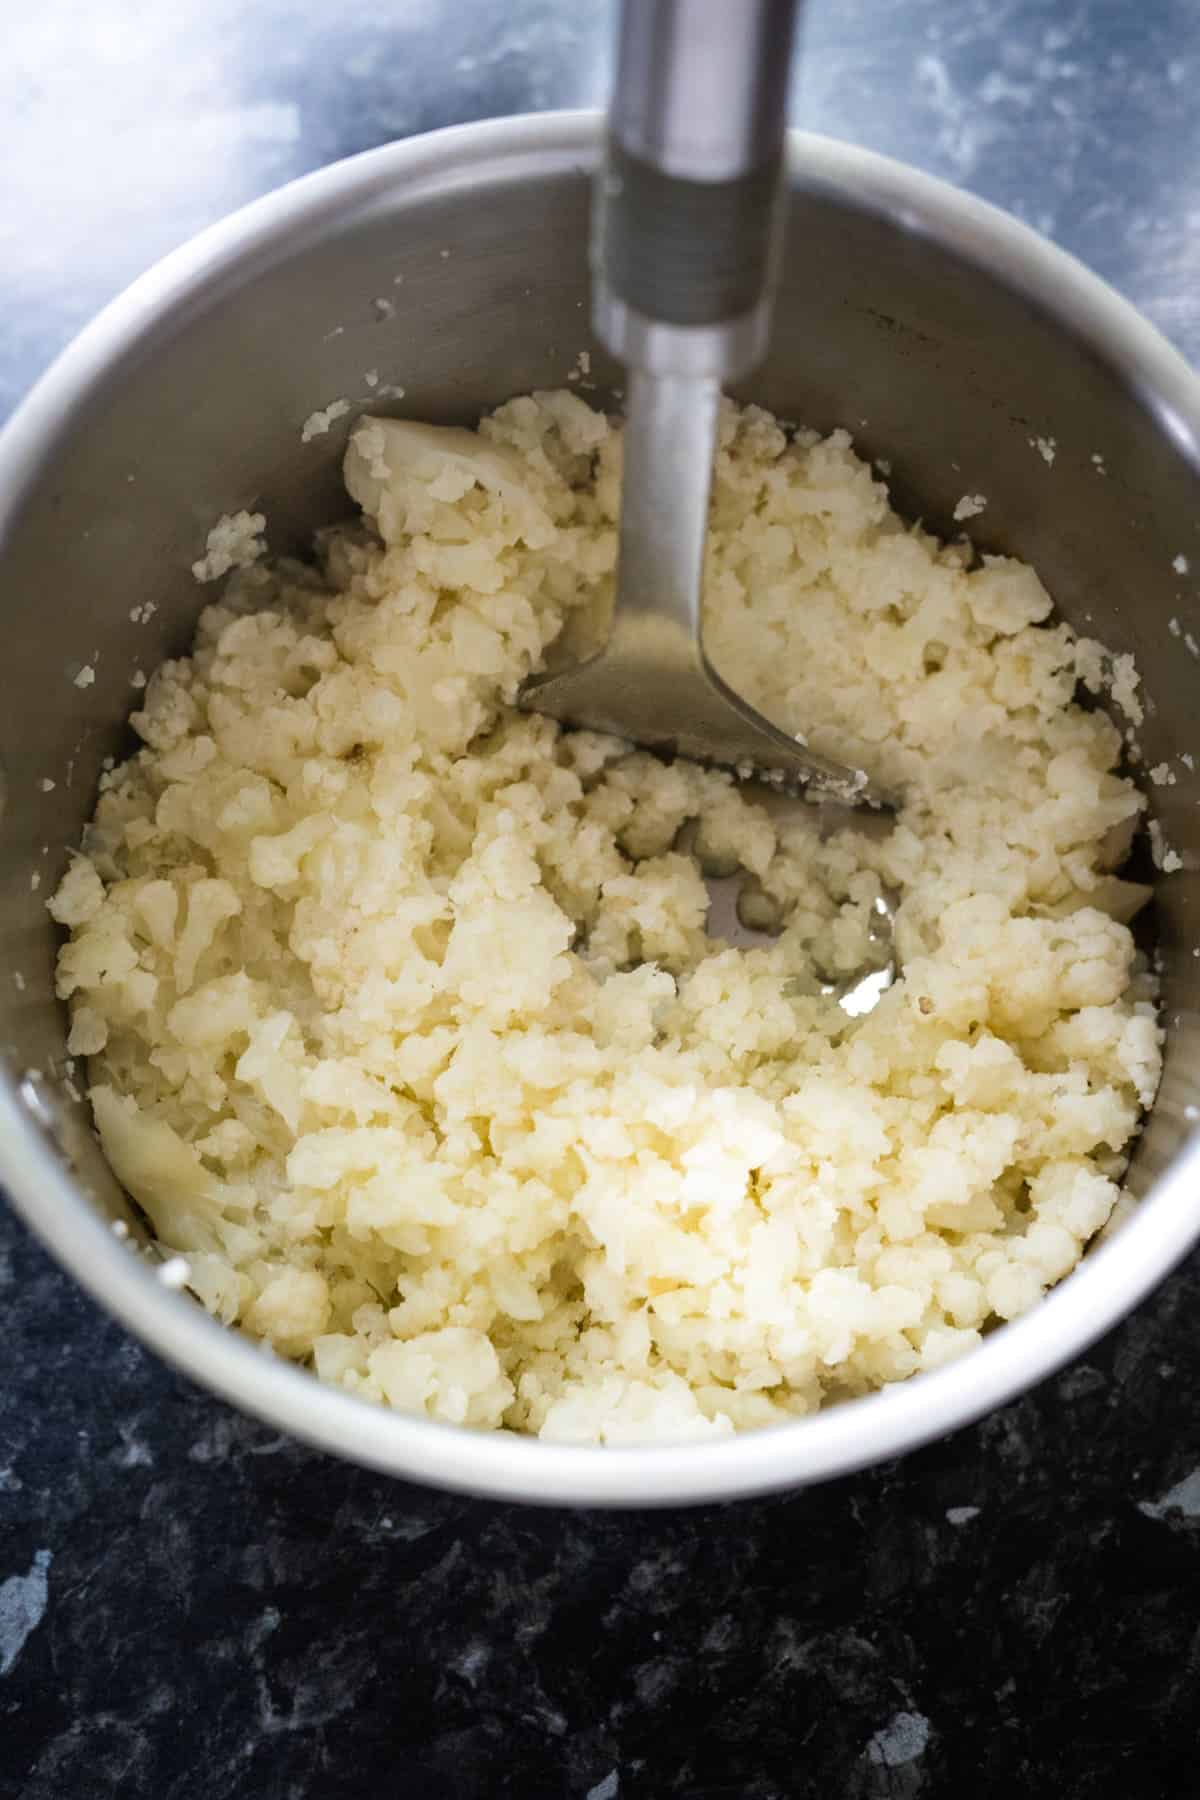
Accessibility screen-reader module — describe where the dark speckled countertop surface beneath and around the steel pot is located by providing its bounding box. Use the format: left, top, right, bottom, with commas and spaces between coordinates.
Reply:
0, 0, 1200, 1800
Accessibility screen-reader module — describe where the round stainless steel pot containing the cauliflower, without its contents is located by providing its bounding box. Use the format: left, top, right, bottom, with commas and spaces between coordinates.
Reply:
0, 105, 1200, 1505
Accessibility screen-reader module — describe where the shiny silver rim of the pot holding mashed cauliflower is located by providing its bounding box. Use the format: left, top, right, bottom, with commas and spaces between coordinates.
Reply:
0, 112, 1200, 1507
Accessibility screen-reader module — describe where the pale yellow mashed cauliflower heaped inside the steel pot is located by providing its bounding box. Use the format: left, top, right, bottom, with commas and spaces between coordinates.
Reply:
50, 394, 1160, 1444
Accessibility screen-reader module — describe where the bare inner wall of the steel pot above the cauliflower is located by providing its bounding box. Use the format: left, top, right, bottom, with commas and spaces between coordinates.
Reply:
0, 153, 1200, 1238
